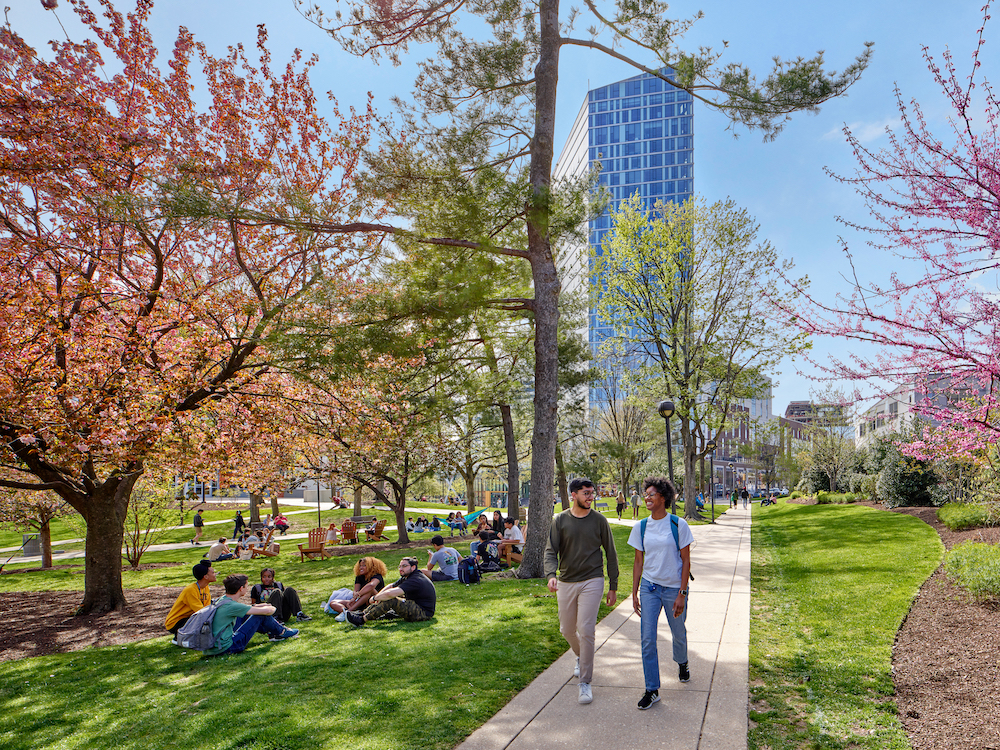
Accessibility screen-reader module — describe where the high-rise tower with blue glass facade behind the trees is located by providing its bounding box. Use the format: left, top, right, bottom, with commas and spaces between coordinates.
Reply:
553, 70, 694, 407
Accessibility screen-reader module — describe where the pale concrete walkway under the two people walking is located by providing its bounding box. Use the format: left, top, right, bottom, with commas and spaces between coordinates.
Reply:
459, 508, 750, 750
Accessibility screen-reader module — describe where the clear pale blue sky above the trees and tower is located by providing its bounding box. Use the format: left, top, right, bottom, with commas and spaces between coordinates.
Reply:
13, 0, 1000, 414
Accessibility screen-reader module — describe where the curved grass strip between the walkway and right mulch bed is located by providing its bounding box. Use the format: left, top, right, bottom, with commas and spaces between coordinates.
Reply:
748, 501, 943, 750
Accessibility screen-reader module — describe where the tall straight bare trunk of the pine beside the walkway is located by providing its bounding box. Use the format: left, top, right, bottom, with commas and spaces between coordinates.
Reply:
517, 0, 560, 578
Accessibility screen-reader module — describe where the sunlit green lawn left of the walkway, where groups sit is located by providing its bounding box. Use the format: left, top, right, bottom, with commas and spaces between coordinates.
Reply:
0, 525, 638, 750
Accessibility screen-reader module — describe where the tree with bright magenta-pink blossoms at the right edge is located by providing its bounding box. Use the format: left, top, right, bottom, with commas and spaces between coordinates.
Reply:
778, 3, 1000, 458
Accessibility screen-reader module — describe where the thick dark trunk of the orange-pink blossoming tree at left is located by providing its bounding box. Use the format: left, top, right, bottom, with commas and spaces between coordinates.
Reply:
76, 470, 142, 615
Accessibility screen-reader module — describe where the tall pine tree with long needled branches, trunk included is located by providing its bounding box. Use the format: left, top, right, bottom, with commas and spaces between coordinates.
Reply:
297, 0, 870, 577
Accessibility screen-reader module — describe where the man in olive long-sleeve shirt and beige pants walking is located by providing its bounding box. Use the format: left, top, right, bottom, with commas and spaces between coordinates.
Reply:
545, 478, 618, 703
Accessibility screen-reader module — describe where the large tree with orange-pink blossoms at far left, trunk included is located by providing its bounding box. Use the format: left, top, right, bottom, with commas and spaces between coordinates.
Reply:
0, 0, 373, 613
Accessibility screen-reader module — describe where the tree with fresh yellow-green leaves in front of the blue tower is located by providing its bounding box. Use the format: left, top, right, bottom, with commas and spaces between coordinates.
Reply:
594, 196, 804, 518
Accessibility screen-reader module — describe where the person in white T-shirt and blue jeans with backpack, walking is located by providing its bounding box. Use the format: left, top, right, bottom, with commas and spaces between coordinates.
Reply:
628, 477, 694, 711
